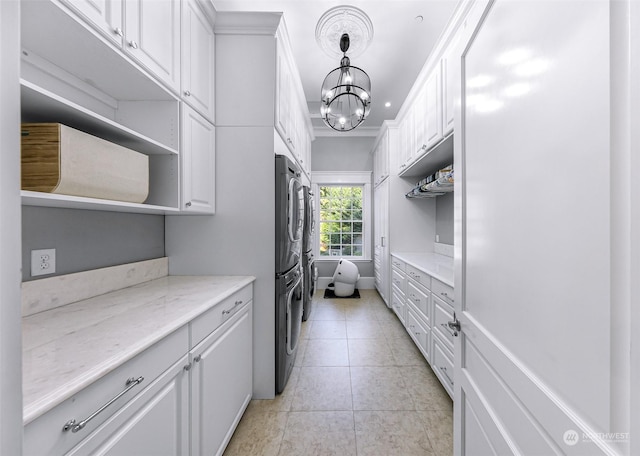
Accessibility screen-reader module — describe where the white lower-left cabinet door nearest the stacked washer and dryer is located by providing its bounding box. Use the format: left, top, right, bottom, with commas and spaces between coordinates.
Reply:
191, 303, 253, 455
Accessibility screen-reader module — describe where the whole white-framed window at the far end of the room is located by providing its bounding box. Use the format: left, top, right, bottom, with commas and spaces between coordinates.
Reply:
314, 173, 371, 260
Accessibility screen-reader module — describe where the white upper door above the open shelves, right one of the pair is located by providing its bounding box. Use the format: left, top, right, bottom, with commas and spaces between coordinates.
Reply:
124, 0, 180, 92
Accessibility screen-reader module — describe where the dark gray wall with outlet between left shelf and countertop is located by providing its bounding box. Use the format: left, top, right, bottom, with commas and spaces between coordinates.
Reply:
22, 206, 164, 282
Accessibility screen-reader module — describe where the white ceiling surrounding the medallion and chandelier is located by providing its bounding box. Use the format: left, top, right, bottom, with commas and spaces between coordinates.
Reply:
213, 0, 458, 136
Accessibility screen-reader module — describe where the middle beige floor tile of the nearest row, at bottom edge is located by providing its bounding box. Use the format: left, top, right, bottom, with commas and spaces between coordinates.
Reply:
279, 411, 356, 456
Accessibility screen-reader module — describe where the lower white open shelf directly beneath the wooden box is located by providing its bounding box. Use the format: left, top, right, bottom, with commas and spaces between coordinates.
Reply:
20, 190, 179, 214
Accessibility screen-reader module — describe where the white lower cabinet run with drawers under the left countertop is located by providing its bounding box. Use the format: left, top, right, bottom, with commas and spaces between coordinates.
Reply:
23, 285, 253, 456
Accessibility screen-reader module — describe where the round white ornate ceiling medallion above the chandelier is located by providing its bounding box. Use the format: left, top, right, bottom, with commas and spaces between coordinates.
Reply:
316, 5, 373, 59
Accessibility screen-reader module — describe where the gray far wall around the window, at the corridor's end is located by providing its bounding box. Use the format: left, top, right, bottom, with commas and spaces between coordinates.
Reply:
311, 137, 375, 277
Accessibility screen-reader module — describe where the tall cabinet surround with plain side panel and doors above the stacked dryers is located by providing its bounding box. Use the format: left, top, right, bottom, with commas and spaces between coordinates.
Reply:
165, 12, 311, 399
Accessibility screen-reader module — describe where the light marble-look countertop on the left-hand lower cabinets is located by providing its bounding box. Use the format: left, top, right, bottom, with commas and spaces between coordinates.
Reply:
22, 276, 255, 424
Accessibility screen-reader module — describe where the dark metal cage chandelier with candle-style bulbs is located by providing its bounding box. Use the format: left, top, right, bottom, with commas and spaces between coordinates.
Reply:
320, 33, 371, 131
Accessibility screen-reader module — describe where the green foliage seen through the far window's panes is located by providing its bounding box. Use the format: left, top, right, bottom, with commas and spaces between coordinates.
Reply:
320, 185, 364, 257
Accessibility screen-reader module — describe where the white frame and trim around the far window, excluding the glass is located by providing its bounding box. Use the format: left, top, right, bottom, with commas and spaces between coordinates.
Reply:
311, 171, 373, 261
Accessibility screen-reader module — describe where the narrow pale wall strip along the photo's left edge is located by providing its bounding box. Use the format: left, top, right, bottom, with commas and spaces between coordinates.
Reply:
0, 0, 22, 455
